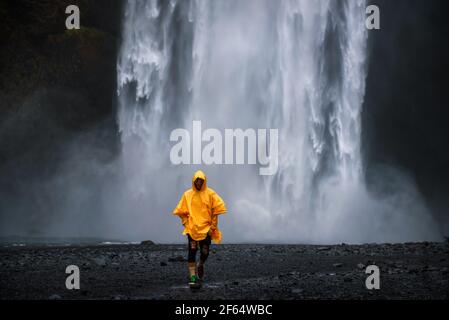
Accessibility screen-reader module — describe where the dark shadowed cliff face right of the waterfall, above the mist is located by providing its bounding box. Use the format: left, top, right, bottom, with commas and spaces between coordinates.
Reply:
362, 0, 449, 222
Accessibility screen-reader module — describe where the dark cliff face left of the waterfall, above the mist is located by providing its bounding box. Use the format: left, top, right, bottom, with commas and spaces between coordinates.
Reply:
0, 0, 122, 178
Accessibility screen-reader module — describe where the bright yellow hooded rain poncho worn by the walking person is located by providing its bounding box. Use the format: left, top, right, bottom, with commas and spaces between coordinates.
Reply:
173, 170, 226, 243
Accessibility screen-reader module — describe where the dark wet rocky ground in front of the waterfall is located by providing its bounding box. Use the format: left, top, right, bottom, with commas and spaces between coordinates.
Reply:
0, 243, 449, 300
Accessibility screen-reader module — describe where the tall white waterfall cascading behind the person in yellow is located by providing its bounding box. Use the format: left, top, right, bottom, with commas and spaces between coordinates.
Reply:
118, 0, 440, 242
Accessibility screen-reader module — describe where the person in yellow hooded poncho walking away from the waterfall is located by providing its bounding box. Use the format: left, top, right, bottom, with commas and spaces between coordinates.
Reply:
173, 170, 226, 288
